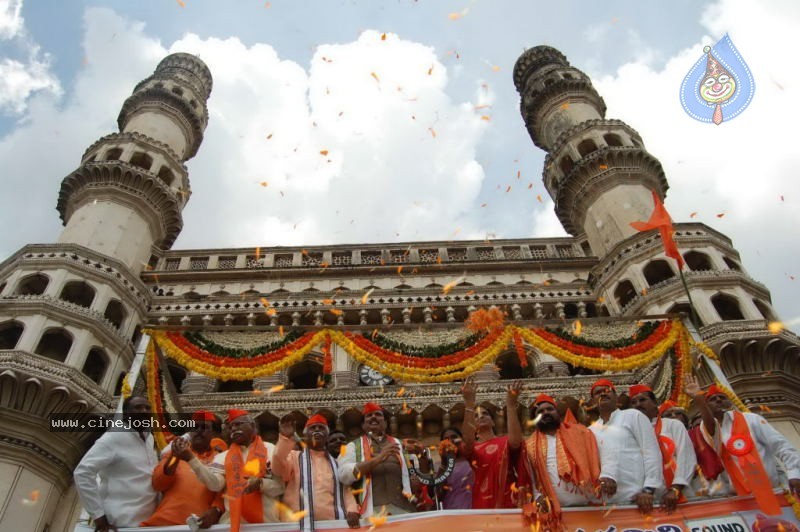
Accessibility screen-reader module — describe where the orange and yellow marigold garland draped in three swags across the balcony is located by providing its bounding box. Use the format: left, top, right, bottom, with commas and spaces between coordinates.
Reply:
145, 321, 720, 390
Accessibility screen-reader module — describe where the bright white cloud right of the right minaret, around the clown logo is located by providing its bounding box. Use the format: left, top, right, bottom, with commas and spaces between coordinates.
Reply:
595, 0, 800, 318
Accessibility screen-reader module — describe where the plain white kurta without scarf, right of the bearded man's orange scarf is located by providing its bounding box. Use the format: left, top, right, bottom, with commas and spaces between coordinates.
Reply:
589, 408, 664, 504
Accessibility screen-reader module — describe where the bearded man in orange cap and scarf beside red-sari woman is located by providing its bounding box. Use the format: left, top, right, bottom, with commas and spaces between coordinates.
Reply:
517, 394, 600, 522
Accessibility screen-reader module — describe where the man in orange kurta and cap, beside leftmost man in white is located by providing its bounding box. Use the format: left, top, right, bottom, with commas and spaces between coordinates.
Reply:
141, 410, 224, 528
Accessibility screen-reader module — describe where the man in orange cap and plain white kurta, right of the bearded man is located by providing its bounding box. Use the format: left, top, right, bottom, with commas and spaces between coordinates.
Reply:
589, 379, 664, 514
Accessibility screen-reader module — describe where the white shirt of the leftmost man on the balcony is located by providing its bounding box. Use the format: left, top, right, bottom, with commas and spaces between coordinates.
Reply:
73, 431, 158, 527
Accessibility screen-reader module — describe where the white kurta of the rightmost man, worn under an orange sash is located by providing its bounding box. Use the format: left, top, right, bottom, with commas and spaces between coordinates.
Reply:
702, 411, 800, 493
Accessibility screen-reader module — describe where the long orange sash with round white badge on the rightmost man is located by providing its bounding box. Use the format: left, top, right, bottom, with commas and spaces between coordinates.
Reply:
718, 412, 781, 515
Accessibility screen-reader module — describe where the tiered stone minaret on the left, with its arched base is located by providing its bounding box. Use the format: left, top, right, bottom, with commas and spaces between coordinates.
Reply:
0, 53, 212, 530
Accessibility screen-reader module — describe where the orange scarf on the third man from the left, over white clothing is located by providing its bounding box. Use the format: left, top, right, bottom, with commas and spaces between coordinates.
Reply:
225, 436, 267, 532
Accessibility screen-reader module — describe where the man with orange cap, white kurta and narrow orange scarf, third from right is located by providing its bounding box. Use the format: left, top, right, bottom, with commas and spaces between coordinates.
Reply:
628, 384, 697, 513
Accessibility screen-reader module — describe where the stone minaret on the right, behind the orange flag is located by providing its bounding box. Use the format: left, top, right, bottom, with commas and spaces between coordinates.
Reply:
514, 46, 800, 442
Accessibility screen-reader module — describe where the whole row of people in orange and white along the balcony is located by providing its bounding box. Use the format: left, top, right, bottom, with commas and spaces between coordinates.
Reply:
74, 377, 800, 531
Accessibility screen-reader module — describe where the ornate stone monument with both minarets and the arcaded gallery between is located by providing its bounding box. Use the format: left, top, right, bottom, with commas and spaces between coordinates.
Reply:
0, 47, 800, 530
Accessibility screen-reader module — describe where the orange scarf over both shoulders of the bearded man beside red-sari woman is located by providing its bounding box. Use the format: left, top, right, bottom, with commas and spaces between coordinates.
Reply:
525, 418, 600, 520
